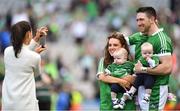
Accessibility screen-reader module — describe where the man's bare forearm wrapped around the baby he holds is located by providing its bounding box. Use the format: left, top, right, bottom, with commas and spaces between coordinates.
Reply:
147, 55, 173, 75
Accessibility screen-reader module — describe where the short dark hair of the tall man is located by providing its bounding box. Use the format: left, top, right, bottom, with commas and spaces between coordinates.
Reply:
136, 7, 157, 19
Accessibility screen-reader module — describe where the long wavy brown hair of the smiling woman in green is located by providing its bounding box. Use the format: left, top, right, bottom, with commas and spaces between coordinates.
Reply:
104, 32, 130, 67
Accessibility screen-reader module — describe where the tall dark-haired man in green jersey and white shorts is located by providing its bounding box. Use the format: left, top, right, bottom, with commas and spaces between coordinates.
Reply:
125, 7, 173, 110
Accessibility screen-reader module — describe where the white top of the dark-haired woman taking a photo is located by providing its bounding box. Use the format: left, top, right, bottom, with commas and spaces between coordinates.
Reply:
2, 41, 41, 111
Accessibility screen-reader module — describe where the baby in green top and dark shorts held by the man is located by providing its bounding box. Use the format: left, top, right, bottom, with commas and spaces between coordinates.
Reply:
119, 42, 159, 109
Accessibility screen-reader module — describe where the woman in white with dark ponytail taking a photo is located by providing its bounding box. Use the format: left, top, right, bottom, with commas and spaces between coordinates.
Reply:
2, 21, 47, 111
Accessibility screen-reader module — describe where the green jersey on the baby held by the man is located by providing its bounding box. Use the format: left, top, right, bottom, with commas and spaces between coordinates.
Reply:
139, 55, 160, 67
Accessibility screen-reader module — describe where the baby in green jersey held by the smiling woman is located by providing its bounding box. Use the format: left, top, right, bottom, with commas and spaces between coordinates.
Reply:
105, 48, 134, 109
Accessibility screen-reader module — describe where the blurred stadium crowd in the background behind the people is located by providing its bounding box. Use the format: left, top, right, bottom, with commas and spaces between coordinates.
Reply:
0, 0, 180, 110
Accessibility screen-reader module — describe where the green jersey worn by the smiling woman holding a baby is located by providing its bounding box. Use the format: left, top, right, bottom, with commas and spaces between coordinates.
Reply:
97, 58, 136, 111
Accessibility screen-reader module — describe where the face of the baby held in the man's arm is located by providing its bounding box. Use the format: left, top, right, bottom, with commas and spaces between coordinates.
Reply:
141, 47, 153, 59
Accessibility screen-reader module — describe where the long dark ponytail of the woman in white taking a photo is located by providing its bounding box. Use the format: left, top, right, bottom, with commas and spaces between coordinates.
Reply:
11, 21, 31, 58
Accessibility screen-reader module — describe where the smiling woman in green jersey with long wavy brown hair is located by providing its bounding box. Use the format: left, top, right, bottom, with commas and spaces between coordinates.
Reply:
97, 32, 136, 110
